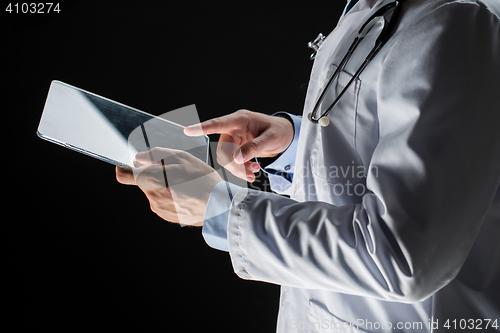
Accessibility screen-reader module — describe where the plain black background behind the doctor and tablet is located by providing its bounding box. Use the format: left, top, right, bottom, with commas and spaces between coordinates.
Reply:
0, 0, 345, 333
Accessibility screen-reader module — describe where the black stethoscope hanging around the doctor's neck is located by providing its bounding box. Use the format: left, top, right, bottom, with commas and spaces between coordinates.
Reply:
307, 0, 405, 127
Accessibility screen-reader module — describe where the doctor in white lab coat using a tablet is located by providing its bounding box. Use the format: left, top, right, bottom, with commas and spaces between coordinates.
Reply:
117, 0, 500, 332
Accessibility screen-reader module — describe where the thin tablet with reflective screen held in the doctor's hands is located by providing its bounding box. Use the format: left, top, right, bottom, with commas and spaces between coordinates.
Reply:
37, 81, 209, 167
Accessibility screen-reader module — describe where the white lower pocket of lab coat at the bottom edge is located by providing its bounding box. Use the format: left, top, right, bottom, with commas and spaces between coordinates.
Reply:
306, 300, 367, 333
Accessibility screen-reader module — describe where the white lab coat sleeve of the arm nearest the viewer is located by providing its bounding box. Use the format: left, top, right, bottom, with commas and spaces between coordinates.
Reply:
228, 3, 500, 302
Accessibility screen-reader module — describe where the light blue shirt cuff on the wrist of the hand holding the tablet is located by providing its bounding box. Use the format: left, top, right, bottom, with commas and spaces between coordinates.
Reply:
202, 181, 242, 252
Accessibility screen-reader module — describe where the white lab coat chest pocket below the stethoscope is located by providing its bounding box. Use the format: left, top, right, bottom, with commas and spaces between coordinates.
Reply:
310, 65, 363, 185
